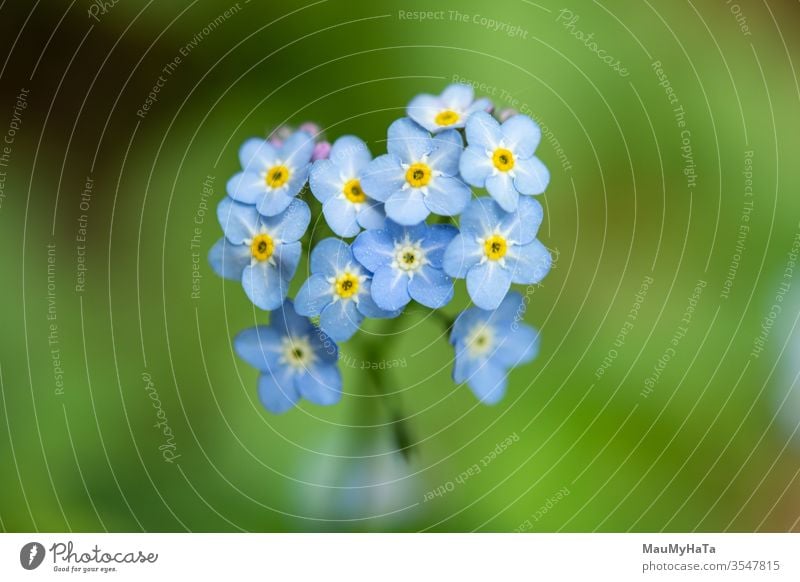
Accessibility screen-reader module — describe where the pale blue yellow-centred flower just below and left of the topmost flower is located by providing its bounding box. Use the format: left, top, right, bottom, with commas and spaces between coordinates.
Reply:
361, 118, 472, 226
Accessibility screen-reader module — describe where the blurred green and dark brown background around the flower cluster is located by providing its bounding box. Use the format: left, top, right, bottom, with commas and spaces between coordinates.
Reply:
0, 0, 800, 531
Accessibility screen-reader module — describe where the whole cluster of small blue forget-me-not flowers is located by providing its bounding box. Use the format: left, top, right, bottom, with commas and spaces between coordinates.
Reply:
209, 84, 551, 413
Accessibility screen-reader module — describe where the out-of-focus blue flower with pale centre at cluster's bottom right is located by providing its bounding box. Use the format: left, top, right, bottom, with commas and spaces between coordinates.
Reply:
450, 292, 539, 404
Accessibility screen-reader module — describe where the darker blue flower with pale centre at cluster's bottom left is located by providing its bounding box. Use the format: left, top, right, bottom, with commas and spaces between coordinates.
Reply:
233, 300, 342, 414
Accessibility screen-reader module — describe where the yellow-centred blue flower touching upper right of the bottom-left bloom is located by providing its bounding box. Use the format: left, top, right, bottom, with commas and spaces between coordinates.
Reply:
295, 238, 399, 342
